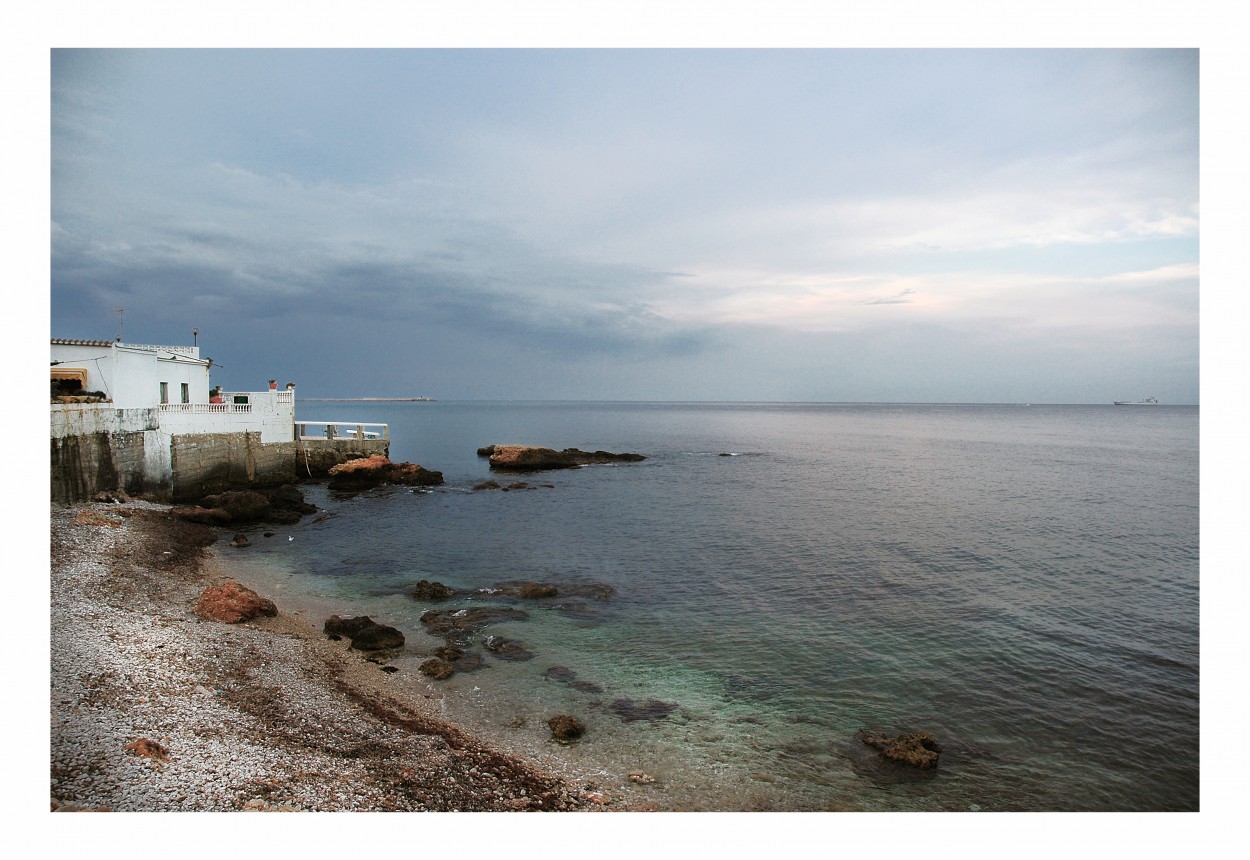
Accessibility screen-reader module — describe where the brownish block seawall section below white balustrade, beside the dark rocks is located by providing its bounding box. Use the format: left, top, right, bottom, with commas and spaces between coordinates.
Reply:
170, 433, 296, 501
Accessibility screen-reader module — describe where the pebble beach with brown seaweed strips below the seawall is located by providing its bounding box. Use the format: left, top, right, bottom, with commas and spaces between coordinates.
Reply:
51, 501, 595, 811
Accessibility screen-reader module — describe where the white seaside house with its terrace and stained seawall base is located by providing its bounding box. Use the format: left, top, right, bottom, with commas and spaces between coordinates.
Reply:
51, 339, 390, 503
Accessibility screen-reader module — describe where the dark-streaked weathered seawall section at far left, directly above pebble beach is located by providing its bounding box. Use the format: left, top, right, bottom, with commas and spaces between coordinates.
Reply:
51, 430, 170, 503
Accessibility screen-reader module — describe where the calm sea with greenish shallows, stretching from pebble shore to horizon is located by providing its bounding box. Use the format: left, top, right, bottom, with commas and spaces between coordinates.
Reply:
235, 401, 1199, 811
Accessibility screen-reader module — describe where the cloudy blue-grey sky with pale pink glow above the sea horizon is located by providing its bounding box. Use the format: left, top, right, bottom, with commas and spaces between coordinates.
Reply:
51, 49, 1199, 404
